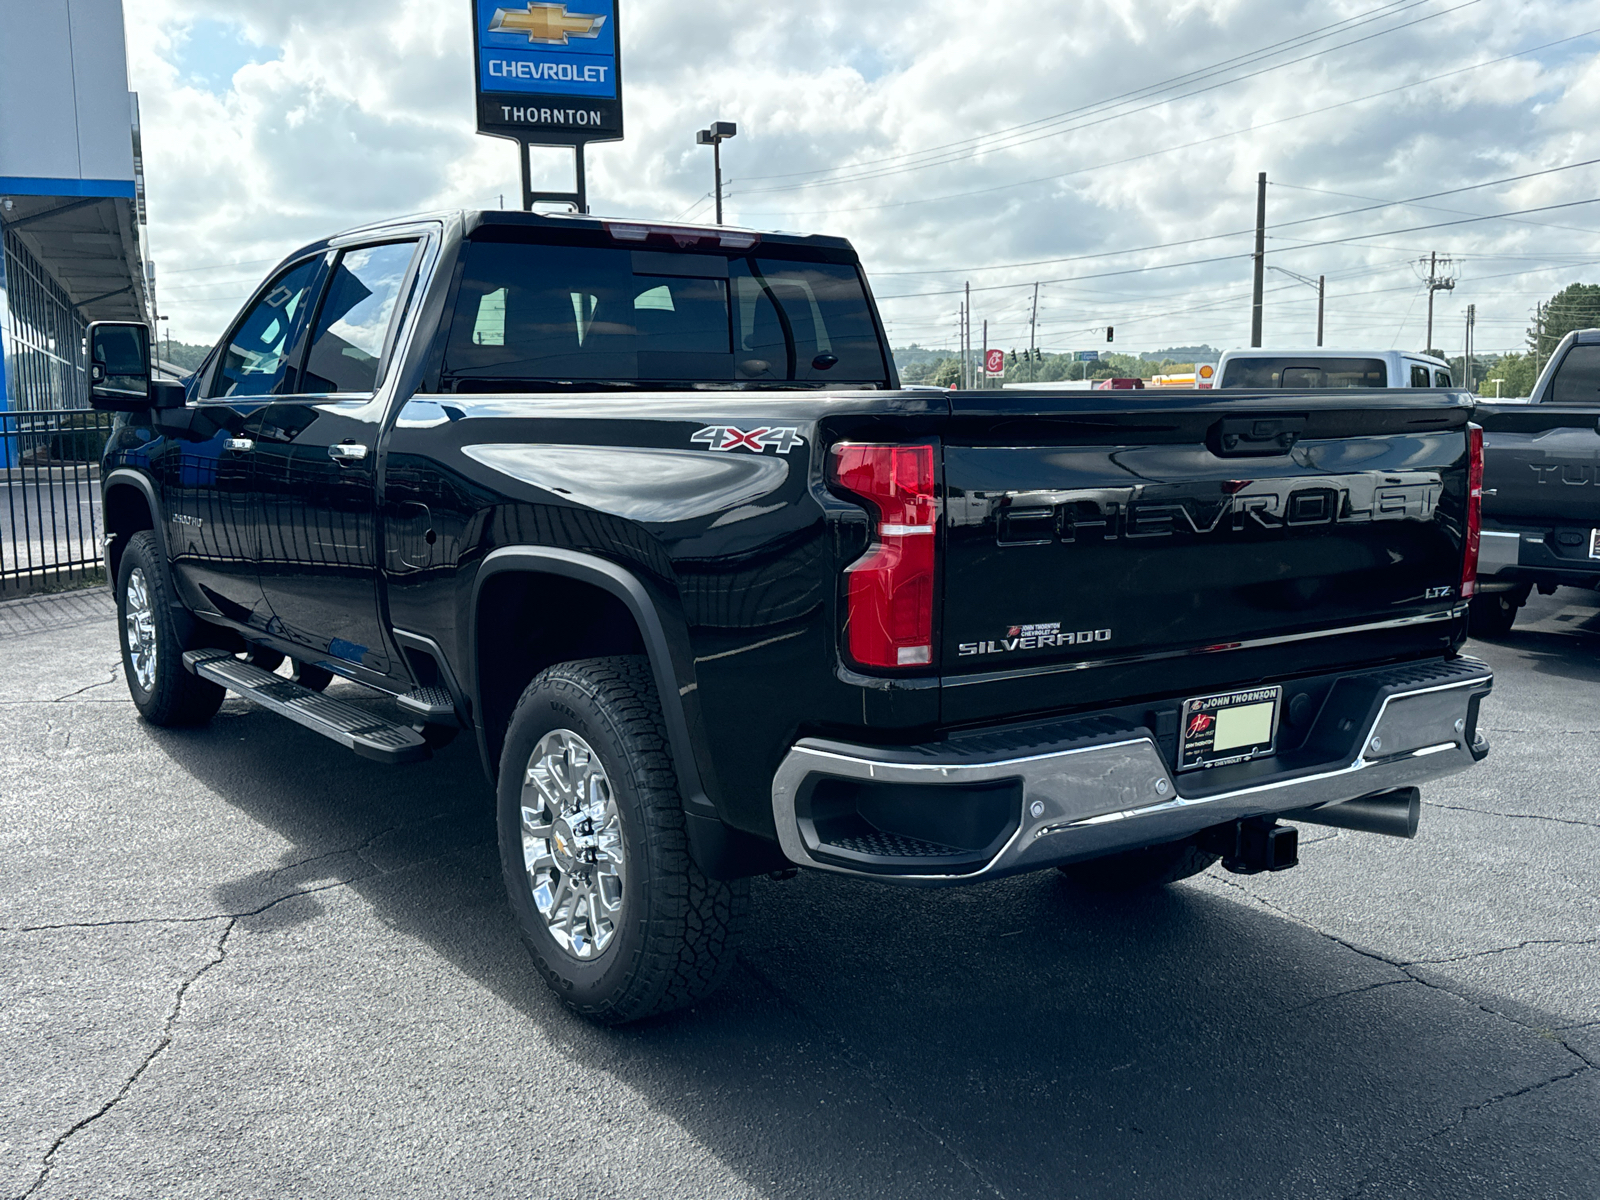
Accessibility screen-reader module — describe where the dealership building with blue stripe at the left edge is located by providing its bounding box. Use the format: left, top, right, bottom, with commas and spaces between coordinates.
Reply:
0, 0, 155, 413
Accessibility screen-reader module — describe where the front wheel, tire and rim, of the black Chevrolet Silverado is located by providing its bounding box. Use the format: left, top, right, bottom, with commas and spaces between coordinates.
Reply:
117, 530, 227, 726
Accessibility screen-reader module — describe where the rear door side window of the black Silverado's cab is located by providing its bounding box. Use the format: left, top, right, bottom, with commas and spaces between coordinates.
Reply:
304, 242, 418, 394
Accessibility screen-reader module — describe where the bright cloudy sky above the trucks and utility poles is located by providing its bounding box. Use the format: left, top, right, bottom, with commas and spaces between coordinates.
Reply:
125, 0, 1600, 361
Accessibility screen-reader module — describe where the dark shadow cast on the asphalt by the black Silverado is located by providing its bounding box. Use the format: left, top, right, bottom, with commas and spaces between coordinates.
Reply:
150, 704, 1595, 1200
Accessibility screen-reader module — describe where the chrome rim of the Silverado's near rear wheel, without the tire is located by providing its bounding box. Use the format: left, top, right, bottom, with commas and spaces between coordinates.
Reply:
522, 730, 624, 962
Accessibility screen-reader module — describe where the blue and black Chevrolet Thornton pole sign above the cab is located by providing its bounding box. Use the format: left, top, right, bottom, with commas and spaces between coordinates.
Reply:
472, 0, 622, 208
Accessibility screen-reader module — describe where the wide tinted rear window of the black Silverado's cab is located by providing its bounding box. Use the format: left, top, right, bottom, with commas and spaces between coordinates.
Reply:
442, 242, 888, 390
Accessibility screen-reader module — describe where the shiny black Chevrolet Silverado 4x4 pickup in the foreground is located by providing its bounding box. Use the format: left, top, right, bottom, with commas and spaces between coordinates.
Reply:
88, 213, 1491, 1022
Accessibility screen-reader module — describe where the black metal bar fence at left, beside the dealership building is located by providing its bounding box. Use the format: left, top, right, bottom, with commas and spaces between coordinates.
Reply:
0, 408, 114, 597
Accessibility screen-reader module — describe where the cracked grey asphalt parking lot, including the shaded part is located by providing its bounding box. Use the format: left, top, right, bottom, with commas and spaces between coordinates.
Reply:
0, 590, 1600, 1200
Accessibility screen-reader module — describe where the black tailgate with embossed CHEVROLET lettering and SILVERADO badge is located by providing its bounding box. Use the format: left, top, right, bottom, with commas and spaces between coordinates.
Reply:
941, 392, 1469, 720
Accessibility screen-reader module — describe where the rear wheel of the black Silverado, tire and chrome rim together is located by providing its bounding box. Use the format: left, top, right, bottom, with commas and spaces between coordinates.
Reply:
498, 658, 750, 1024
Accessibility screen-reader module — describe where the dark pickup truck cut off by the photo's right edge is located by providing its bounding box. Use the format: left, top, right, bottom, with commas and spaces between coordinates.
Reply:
1472, 330, 1600, 637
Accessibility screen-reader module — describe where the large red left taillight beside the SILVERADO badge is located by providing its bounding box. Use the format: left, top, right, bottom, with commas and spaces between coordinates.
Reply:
834, 442, 939, 667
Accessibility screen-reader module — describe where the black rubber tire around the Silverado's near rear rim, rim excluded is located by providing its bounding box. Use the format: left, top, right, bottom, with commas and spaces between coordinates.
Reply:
498, 656, 750, 1026
